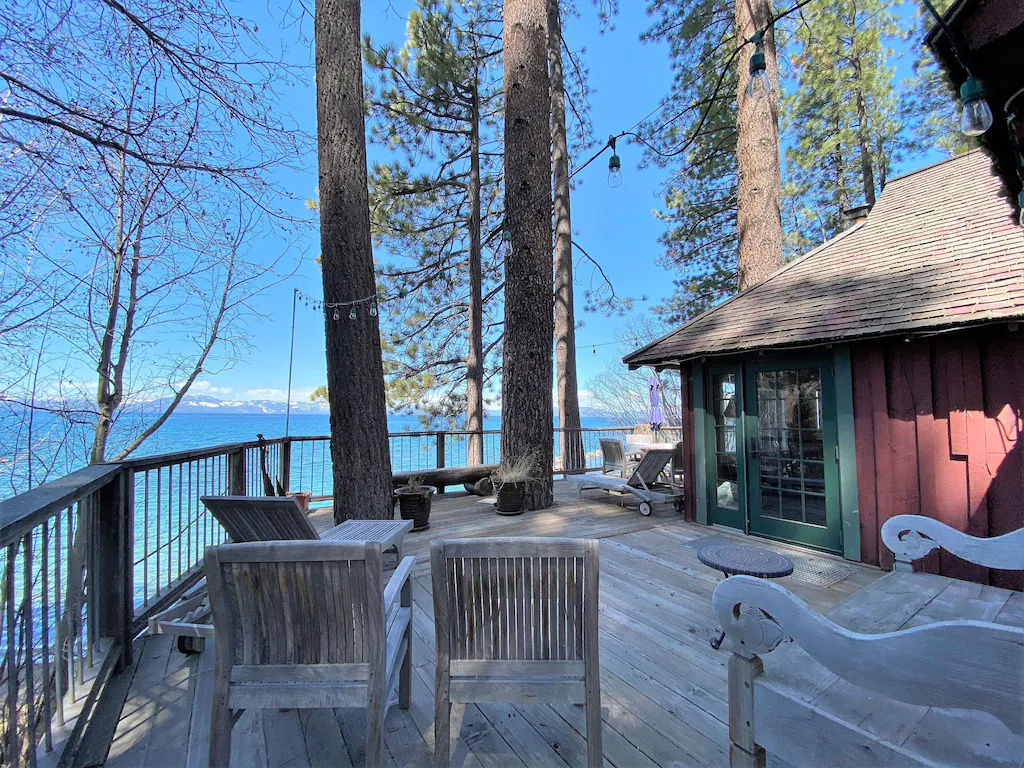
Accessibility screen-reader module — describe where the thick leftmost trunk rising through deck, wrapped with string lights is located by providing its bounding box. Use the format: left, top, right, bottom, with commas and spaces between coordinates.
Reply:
314, 0, 393, 522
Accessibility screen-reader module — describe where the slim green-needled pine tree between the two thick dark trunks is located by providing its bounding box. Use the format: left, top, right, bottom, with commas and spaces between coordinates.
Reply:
365, 0, 503, 463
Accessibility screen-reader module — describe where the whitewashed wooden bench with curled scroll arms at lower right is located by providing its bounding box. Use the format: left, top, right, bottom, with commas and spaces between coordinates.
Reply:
714, 515, 1024, 768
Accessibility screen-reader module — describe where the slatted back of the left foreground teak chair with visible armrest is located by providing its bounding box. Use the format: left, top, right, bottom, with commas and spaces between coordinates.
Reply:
206, 542, 384, 667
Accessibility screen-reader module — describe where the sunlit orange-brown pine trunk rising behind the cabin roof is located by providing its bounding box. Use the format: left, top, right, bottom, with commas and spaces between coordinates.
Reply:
736, 0, 782, 290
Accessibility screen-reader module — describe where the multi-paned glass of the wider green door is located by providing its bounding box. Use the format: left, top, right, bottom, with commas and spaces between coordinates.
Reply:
756, 368, 825, 525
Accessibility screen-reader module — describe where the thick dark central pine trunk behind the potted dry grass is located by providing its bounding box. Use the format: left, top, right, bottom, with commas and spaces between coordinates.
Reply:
502, 0, 554, 510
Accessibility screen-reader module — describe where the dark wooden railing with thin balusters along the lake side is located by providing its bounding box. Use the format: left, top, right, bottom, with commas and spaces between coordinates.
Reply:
0, 427, 672, 766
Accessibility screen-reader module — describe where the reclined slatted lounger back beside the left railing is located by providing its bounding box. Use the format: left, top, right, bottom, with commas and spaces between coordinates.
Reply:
200, 496, 319, 544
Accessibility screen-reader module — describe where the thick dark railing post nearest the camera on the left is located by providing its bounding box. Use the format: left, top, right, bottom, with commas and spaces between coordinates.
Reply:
94, 469, 135, 672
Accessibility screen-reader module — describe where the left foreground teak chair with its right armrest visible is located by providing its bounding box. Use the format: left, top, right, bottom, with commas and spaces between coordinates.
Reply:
206, 542, 416, 767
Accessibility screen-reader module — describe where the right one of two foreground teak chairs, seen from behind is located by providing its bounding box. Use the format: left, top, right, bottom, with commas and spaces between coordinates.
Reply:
430, 539, 601, 767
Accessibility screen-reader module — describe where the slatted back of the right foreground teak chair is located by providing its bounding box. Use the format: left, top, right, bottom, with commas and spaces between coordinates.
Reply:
431, 539, 599, 662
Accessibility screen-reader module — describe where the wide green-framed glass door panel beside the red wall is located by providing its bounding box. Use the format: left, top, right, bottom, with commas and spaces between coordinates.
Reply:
742, 357, 842, 552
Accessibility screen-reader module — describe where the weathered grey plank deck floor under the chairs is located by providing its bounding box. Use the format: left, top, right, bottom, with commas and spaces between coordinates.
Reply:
94, 482, 881, 768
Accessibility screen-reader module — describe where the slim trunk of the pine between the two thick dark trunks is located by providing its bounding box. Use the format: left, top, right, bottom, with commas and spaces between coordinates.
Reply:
466, 73, 483, 464
